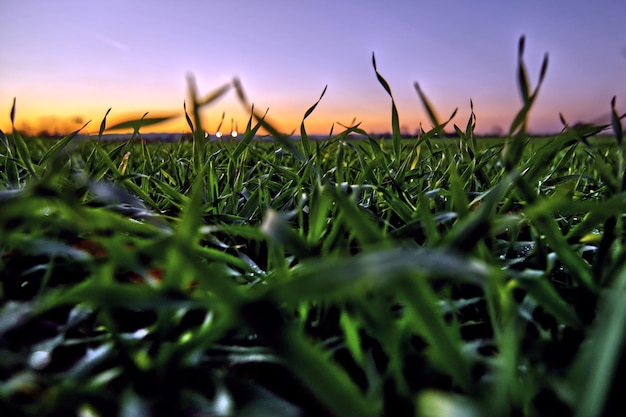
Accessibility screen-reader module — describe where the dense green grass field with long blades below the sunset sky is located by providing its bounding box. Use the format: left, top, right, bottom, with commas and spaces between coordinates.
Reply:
0, 40, 626, 417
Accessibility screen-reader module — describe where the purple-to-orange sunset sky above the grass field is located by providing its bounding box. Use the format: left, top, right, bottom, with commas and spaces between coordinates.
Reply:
0, 0, 626, 135
